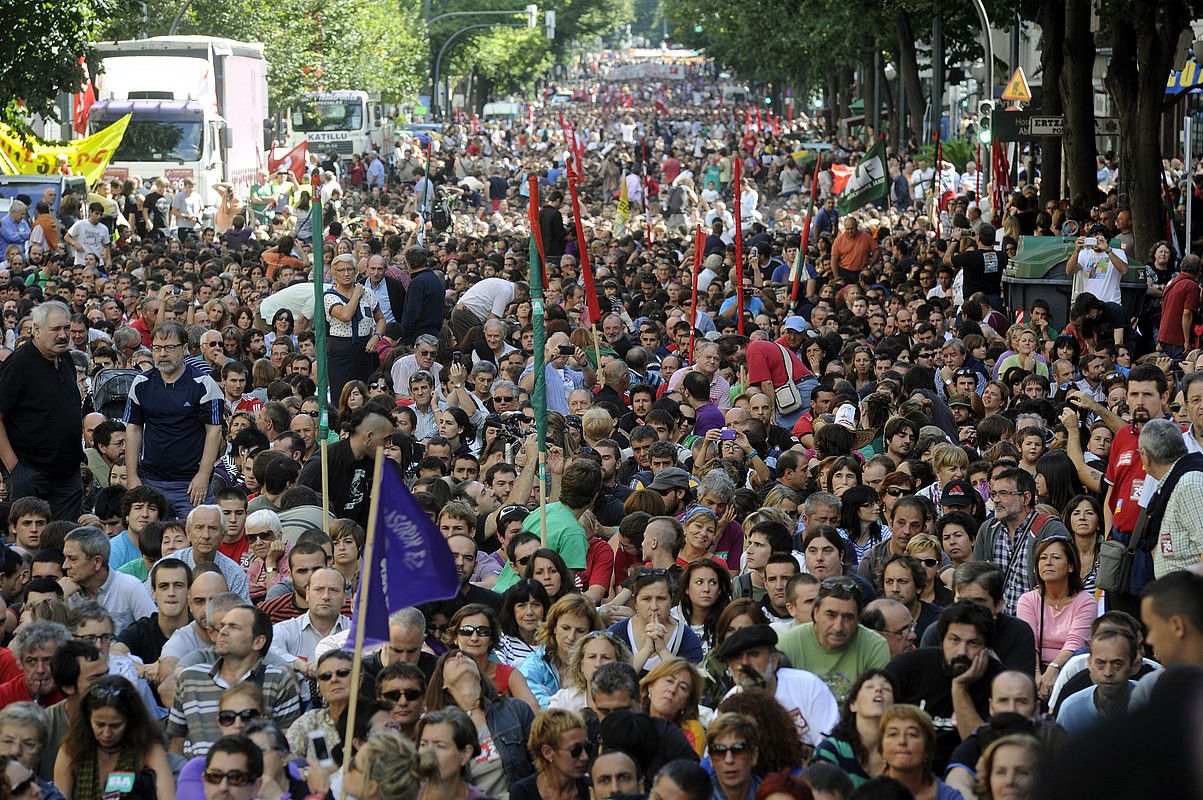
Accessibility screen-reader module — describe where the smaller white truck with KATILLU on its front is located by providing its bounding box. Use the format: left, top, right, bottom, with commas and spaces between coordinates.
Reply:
289, 89, 389, 159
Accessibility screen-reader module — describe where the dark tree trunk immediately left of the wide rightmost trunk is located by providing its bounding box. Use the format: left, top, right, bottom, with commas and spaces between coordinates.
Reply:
1063, 0, 1101, 203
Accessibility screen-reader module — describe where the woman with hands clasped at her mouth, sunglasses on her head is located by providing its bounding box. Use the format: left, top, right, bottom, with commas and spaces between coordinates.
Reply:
609, 569, 704, 671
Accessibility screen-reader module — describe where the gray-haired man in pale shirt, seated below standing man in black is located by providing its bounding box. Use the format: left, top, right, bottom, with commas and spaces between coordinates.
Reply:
63, 526, 158, 636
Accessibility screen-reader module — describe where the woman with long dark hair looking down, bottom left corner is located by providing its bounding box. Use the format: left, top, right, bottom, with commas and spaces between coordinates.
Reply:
54, 675, 176, 800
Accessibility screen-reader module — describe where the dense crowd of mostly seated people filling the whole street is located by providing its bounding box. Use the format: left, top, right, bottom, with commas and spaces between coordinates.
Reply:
0, 68, 1203, 800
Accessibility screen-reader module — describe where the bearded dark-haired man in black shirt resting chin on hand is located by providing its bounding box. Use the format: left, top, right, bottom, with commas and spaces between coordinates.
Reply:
885, 600, 1003, 775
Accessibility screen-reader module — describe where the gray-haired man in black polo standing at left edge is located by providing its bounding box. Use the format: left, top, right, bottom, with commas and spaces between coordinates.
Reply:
0, 301, 84, 522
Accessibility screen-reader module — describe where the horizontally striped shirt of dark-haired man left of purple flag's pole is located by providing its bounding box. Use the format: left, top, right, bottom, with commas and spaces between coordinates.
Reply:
167, 658, 301, 758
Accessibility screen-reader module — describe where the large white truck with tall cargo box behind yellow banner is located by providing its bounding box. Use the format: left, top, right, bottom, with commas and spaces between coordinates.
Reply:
88, 36, 268, 206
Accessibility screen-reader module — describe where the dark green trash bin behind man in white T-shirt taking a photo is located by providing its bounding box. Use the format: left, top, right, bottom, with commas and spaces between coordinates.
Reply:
1002, 236, 1146, 330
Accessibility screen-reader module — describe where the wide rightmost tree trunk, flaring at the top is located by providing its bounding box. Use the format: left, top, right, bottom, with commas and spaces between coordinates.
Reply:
1100, 0, 1192, 257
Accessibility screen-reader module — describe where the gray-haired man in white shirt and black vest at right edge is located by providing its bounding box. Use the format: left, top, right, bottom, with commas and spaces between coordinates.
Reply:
1138, 420, 1203, 577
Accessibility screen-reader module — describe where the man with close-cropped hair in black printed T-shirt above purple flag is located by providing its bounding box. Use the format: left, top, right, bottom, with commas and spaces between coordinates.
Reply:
297, 403, 393, 528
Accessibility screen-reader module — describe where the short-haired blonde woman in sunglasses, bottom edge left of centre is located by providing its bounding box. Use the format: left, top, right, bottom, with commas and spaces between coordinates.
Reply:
510, 709, 589, 800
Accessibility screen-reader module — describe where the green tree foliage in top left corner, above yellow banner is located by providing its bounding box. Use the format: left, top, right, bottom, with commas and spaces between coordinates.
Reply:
0, 0, 115, 132
